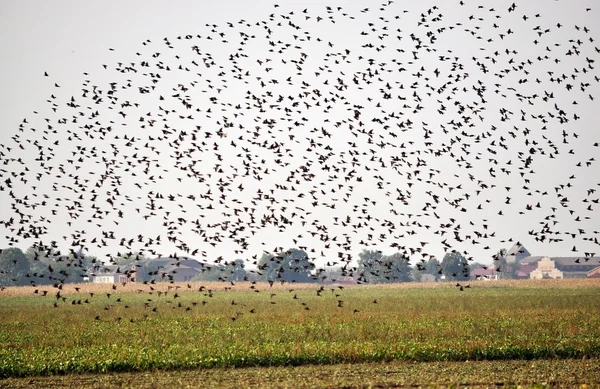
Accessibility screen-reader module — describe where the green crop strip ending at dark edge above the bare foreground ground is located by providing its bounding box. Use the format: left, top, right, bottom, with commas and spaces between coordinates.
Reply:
0, 280, 600, 377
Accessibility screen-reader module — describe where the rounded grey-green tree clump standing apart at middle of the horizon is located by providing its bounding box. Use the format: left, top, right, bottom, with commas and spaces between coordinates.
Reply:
258, 248, 317, 282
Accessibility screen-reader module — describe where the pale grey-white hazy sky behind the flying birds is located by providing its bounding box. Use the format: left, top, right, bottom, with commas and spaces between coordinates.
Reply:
0, 0, 600, 263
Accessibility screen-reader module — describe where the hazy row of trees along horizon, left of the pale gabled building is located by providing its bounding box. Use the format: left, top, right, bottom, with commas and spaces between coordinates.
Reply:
0, 246, 482, 286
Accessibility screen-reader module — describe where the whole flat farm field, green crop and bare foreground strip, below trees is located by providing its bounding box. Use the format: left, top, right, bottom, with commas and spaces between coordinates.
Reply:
0, 280, 600, 387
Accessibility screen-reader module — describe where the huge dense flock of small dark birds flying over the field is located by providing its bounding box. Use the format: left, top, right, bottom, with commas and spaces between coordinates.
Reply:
0, 1, 600, 320
